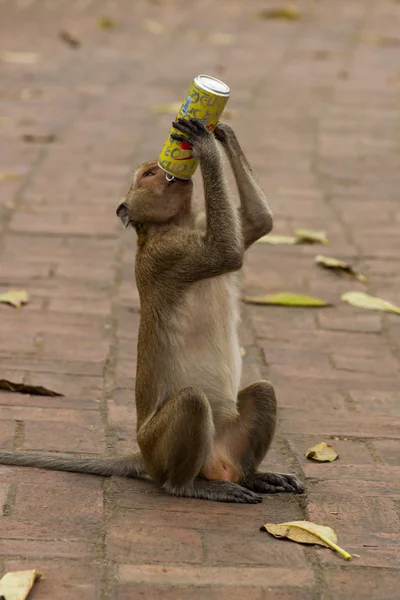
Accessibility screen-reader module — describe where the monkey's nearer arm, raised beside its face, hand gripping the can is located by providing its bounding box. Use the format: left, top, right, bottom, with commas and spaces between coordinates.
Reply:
154, 119, 244, 282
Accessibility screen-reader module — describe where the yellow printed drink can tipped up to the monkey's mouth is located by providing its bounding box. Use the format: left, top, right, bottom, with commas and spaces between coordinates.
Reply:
158, 75, 230, 179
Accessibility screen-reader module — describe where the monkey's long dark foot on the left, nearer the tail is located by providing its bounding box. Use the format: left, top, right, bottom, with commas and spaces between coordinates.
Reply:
164, 479, 262, 504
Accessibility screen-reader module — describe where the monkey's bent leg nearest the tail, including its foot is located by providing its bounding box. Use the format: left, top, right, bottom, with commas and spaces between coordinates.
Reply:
138, 387, 262, 504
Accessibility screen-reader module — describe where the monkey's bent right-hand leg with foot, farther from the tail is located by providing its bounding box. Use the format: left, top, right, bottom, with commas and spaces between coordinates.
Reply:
228, 380, 304, 494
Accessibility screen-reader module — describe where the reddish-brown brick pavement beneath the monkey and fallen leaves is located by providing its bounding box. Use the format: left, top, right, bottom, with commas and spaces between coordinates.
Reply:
0, 0, 400, 600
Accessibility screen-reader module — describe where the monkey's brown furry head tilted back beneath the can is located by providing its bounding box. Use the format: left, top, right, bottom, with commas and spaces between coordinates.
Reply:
117, 161, 193, 227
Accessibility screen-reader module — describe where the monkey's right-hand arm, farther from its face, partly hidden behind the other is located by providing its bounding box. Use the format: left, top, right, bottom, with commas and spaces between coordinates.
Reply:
215, 123, 272, 249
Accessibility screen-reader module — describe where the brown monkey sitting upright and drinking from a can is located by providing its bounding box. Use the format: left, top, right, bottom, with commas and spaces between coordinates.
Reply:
0, 119, 303, 504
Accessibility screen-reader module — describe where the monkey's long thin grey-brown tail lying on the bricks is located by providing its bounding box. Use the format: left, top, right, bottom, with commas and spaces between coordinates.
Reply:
0, 450, 147, 477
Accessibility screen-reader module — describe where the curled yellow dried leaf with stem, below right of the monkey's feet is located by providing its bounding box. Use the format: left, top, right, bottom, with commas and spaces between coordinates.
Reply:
261, 521, 351, 560
